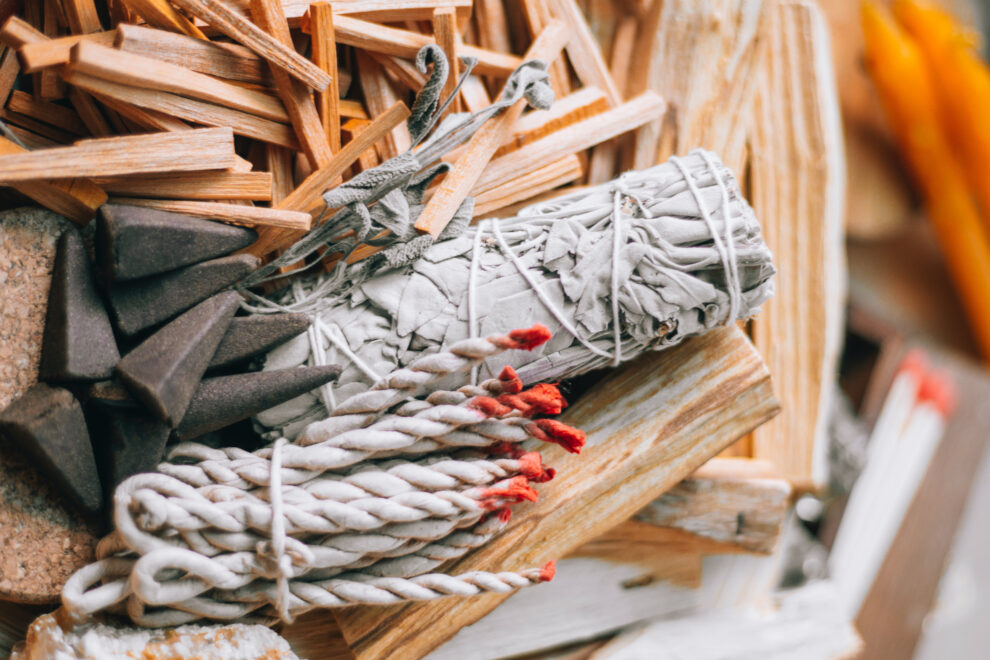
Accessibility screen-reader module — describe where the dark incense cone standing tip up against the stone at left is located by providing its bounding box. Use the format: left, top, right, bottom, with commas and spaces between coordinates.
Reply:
40, 229, 120, 383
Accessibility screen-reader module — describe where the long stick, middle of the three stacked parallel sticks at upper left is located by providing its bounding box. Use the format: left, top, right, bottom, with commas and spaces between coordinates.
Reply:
70, 42, 289, 123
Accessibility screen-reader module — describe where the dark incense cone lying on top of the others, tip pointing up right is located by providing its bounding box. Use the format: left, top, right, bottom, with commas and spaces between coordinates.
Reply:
117, 291, 241, 427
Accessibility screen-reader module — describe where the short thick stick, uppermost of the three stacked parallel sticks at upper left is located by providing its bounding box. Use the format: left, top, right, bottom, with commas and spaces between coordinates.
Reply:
113, 23, 272, 85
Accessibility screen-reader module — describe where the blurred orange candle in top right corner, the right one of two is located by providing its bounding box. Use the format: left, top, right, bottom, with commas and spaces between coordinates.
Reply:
894, 0, 990, 236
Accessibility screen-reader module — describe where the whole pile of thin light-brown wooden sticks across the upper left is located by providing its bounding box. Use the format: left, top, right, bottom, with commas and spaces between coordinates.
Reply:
0, 0, 665, 270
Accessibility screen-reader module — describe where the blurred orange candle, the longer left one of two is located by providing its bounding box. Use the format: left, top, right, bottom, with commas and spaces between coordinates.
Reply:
862, 2, 990, 361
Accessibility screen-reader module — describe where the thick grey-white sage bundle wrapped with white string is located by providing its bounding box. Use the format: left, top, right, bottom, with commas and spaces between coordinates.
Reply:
250, 150, 775, 438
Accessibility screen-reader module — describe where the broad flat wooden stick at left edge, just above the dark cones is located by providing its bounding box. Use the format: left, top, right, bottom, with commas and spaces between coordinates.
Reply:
0, 128, 235, 183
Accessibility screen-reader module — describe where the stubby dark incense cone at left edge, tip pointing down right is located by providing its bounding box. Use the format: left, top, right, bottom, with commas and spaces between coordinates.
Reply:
0, 383, 103, 514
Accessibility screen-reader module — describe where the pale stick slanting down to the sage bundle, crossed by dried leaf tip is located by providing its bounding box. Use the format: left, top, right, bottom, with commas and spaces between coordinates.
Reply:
416, 22, 567, 238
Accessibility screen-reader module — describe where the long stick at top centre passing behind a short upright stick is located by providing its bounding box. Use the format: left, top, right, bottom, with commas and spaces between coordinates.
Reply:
334, 15, 522, 78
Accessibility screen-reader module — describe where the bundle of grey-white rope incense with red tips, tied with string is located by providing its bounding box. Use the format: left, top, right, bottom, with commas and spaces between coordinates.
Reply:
62, 325, 572, 627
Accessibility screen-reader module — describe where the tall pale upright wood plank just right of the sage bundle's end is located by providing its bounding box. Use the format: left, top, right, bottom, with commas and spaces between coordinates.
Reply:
750, 2, 845, 489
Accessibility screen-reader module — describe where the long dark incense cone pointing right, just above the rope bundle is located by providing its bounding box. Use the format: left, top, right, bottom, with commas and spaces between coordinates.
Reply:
172, 365, 340, 440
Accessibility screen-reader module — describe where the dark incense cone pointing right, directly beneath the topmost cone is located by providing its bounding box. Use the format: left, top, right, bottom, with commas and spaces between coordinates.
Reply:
110, 254, 258, 335
